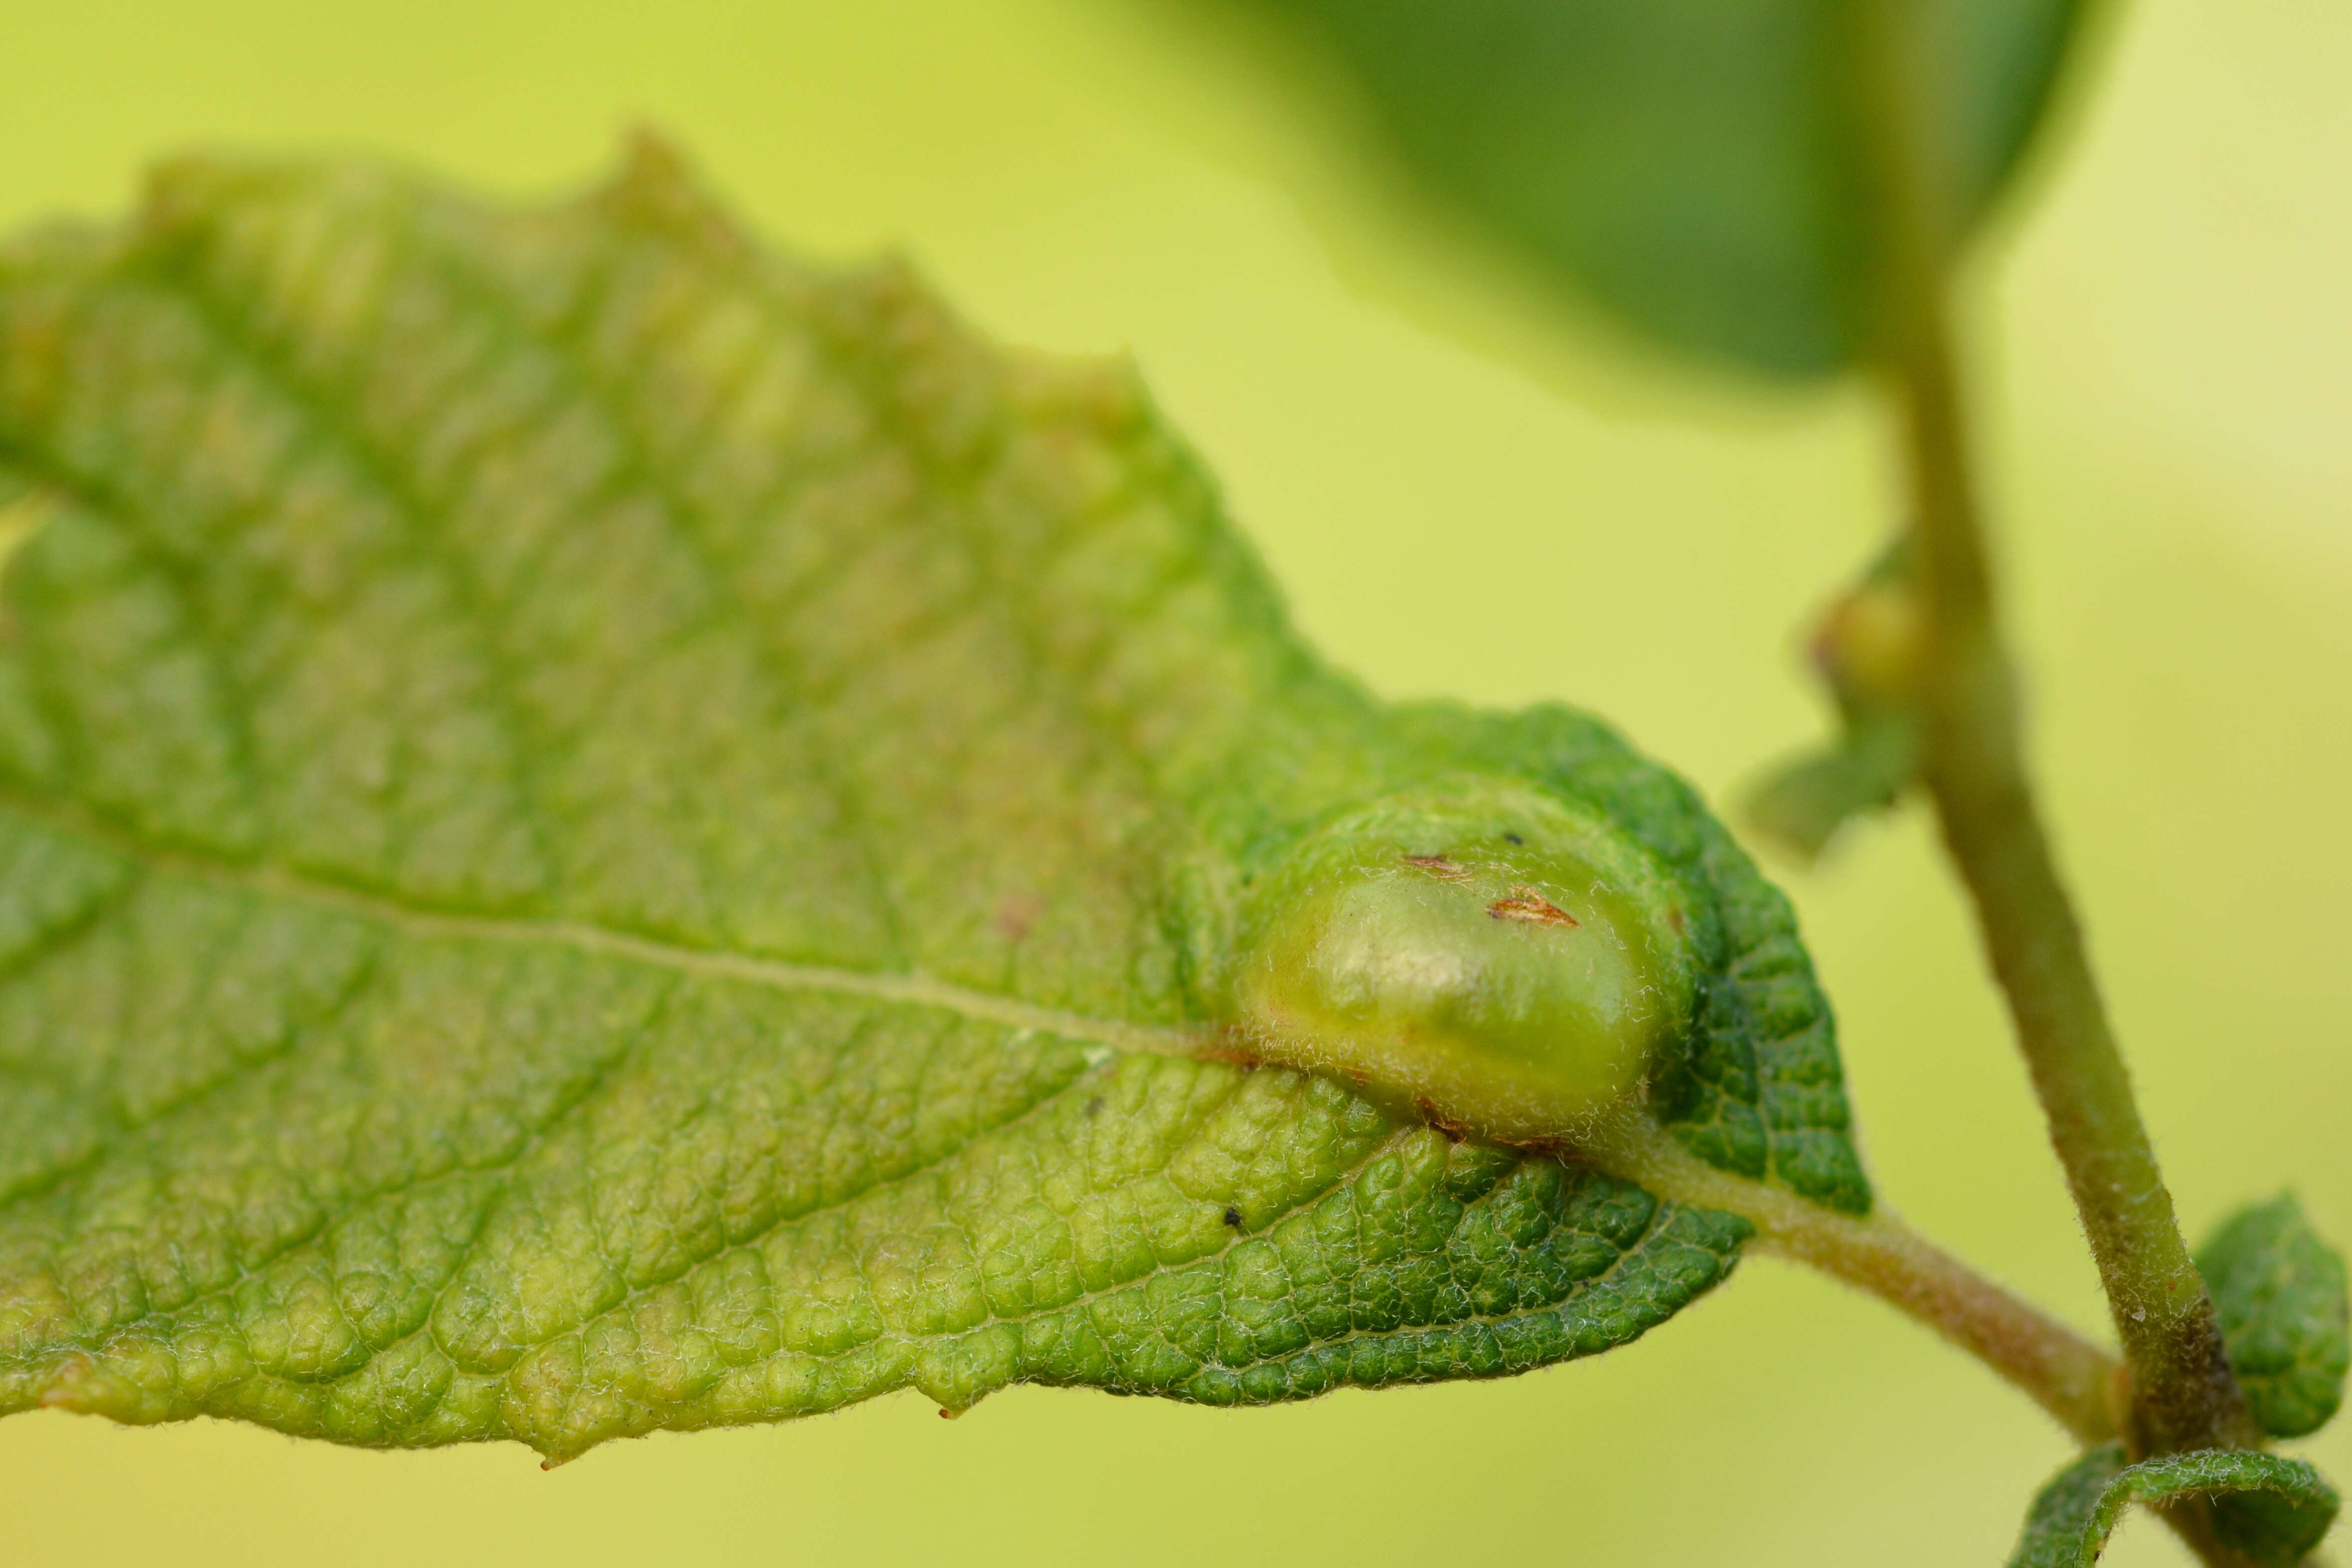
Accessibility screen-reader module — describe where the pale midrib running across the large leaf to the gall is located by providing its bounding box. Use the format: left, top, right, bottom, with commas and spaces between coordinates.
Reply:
0, 787, 1211, 1060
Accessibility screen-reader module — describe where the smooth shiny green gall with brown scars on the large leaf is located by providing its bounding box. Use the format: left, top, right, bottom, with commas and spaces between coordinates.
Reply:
1235, 781, 1694, 1143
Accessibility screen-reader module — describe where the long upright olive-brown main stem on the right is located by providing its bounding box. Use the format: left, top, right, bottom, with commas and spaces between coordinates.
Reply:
1860, 0, 2260, 1453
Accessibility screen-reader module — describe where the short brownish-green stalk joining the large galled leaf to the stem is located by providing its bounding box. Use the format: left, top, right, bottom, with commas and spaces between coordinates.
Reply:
1578, 1117, 2122, 1448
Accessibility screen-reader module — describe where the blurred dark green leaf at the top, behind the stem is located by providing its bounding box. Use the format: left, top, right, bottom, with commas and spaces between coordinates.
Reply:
1254, 0, 2084, 376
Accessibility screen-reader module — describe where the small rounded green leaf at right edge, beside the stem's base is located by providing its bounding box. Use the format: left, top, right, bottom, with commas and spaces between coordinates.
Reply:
2197, 1192, 2352, 1436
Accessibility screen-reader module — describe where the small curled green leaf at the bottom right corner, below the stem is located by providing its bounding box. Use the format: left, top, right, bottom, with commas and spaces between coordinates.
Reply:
2008, 1443, 2336, 1568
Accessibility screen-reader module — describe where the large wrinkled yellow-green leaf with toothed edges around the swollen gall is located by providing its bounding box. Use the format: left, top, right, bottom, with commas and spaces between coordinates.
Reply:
0, 148, 1870, 1455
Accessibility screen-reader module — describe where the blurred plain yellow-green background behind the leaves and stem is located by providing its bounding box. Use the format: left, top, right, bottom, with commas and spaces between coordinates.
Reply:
0, 0, 2352, 1568
